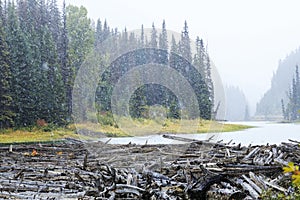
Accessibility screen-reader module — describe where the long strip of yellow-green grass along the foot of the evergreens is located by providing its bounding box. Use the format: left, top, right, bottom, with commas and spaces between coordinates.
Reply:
0, 118, 251, 143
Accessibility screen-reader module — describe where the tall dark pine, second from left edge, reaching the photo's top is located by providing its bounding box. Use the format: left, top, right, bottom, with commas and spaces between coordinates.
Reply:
6, 2, 35, 126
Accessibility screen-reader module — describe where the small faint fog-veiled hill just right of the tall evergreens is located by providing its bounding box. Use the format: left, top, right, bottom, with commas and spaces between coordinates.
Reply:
225, 86, 248, 121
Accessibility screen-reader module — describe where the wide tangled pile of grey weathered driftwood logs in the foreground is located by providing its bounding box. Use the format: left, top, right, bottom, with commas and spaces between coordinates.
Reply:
0, 135, 300, 200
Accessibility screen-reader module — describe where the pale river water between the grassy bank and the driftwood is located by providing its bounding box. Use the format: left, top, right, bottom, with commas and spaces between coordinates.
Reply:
100, 122, 300, 145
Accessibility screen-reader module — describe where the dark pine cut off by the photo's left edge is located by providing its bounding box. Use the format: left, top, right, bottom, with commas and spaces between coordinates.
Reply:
0, 16, 14, 129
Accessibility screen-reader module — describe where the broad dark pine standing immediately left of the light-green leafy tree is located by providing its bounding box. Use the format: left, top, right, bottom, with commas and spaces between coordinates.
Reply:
38, 26, 66, 124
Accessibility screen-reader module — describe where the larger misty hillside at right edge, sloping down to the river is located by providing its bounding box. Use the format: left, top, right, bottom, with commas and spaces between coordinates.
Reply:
255, 48, 300, 120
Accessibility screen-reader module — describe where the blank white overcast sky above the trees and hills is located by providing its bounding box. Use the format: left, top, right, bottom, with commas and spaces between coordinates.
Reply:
60, 0, 300, 111
